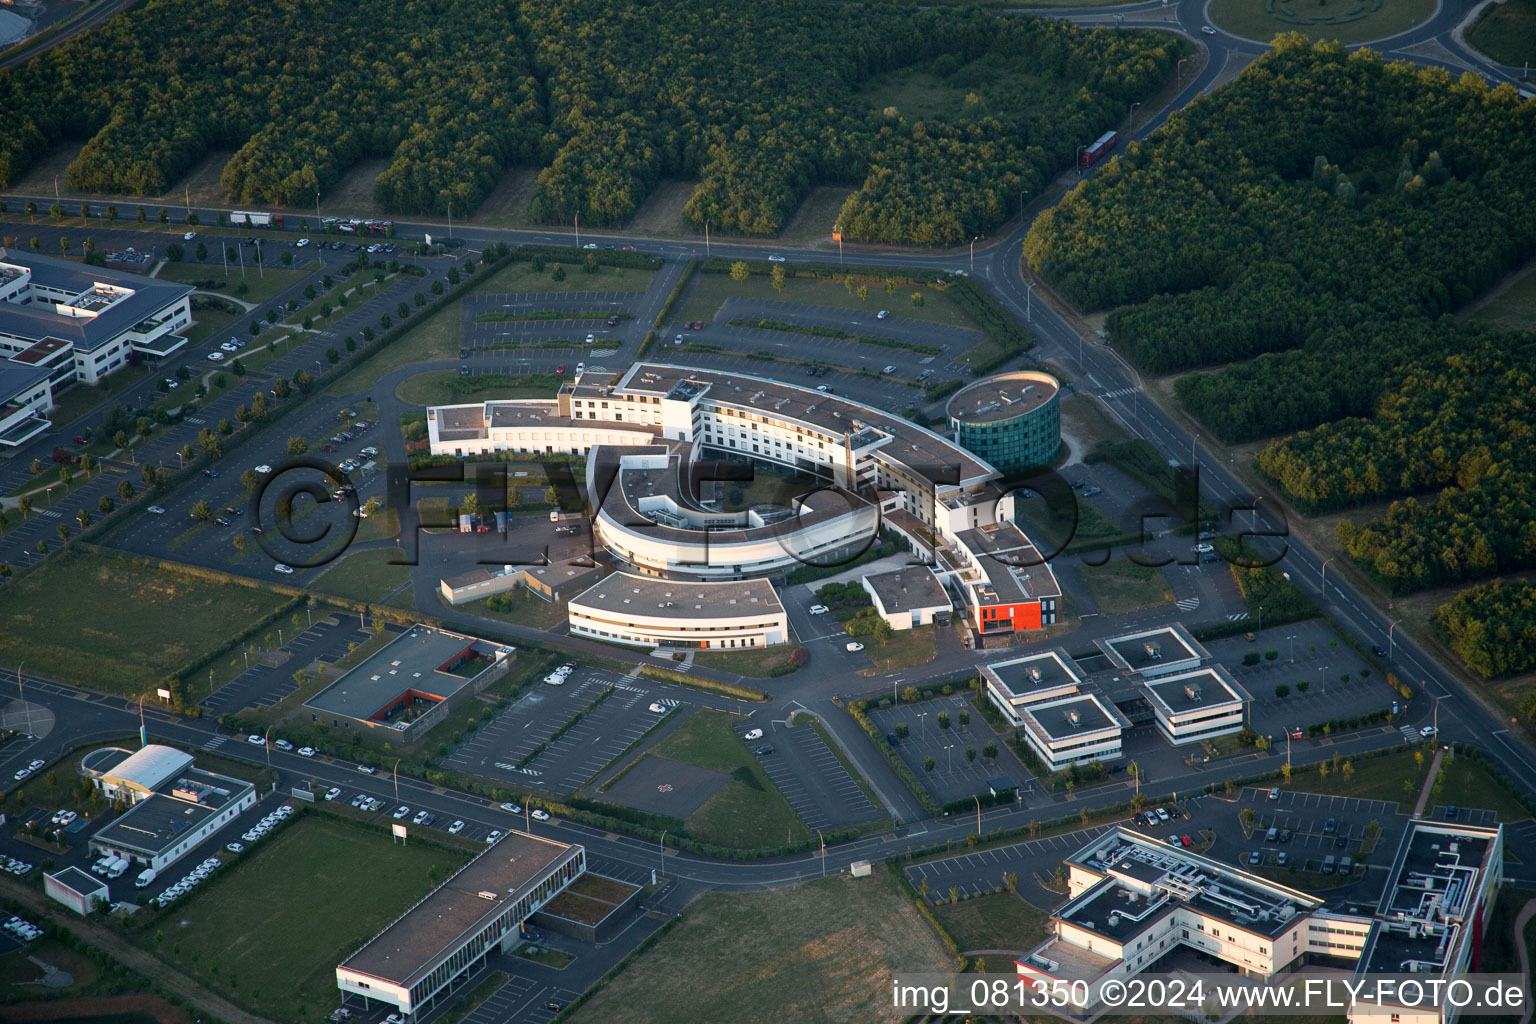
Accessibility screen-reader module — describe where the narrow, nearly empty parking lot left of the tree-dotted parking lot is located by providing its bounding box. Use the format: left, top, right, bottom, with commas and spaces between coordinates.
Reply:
734, 715, 885, 829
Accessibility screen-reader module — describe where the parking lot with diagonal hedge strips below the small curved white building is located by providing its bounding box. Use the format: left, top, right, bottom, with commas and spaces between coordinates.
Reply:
444, 666, 715, 794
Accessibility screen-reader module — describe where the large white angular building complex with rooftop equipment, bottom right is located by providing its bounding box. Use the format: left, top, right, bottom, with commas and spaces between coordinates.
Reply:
1015, 821, 1504, 1024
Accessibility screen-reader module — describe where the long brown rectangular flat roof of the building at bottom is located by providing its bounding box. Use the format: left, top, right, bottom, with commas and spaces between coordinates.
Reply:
341, 829, 581, 989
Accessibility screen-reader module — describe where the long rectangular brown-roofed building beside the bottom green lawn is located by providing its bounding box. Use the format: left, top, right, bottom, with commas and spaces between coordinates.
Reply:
336, 831, 587, 1019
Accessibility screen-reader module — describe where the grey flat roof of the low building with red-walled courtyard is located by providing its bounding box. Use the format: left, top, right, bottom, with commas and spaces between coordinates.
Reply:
304, 623, 513, 718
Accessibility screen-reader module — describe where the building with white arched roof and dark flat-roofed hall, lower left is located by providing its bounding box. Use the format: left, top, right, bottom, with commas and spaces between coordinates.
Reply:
80, 743, 257, 872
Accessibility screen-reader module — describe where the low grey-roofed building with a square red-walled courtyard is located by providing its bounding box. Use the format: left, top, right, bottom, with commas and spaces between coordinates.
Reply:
304, 623, 516, 743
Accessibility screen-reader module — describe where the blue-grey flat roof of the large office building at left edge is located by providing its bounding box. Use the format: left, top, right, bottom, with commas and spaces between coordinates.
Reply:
0, 249, 195, 352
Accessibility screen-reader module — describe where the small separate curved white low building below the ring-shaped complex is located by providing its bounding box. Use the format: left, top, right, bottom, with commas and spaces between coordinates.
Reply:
567, 573, 790, 651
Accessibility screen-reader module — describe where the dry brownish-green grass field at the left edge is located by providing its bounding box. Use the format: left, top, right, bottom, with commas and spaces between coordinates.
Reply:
0, 554, 286, 694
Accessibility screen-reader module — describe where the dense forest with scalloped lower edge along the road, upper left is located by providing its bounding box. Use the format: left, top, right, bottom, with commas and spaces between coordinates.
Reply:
0, 0, 1181, 244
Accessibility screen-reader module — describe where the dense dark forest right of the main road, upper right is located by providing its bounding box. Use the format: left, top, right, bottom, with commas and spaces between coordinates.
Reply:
1025, 35, 1536, 604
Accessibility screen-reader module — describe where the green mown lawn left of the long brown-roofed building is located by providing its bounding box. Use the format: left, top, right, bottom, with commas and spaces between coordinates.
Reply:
138, 814, 468, 1021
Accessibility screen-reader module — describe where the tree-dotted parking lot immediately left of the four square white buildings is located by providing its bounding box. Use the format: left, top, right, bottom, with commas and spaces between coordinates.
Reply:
871, 694, 1034, 803
